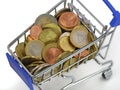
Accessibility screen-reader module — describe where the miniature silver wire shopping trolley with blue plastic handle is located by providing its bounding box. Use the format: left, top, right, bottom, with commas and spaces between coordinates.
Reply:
6, 0, 120, 90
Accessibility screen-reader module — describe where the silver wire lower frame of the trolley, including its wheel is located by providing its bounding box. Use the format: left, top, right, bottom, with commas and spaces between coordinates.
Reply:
61, 59, 113, 90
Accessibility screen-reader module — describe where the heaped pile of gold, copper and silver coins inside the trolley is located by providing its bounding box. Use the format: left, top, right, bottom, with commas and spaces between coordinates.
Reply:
15, 8, 96, 75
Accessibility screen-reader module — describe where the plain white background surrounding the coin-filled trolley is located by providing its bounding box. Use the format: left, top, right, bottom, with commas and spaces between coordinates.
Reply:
0, 0, 120, 90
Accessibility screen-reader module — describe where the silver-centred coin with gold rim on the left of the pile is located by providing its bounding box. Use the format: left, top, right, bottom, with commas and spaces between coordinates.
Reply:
25, 40, 44, 59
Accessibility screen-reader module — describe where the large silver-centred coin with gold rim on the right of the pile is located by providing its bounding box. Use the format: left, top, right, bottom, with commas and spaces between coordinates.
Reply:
70, 25, 89, 48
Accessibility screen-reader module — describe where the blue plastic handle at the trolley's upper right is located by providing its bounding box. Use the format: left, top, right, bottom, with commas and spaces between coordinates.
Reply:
103, 0, 120, 27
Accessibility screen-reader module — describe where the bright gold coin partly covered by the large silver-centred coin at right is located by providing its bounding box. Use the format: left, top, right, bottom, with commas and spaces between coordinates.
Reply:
58, 36, 75, 52
